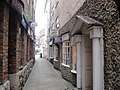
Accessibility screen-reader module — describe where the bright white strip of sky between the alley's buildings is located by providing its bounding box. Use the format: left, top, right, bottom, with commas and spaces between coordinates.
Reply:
35, 0, 46, 36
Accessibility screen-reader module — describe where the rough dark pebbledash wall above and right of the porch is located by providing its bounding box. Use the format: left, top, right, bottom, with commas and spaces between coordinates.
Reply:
77, 0, 120, 90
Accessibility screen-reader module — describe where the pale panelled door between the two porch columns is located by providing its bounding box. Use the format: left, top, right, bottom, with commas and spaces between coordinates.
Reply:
82, 35, 93, 90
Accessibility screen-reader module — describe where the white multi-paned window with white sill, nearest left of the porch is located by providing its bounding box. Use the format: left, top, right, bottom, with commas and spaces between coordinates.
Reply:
62, 41, 70, 65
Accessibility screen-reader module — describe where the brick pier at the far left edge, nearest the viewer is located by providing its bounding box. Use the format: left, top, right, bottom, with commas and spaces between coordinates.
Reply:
0, 1, 9, 84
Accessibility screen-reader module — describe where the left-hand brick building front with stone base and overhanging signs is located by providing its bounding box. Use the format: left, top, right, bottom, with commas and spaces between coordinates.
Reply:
0, 0, 35, 90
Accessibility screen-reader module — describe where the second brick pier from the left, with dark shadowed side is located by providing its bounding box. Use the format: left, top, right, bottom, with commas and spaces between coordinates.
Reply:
8, 11, 20, 74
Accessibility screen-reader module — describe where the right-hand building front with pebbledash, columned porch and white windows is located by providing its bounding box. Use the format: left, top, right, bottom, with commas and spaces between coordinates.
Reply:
49, 0, 120, 90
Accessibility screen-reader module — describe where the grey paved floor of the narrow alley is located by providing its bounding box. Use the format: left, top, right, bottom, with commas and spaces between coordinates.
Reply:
23, 56, 74, 90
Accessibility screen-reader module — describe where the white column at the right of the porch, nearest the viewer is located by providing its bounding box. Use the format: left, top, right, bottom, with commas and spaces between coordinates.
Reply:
90, 26, 104, 90
